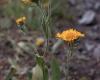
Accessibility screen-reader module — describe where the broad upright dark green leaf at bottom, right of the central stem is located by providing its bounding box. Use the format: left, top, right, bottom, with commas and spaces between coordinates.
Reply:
51, 58, 60, 80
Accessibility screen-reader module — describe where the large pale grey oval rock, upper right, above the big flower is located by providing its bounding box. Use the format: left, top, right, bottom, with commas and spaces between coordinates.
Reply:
78, 10, 96, 25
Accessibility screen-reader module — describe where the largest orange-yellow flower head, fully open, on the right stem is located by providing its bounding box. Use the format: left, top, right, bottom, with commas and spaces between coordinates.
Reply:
56, 29, 84, 42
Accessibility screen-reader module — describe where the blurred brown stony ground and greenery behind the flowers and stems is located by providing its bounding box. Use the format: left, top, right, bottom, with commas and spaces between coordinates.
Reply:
0, 0, 100, 80
